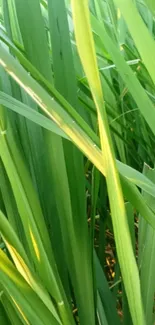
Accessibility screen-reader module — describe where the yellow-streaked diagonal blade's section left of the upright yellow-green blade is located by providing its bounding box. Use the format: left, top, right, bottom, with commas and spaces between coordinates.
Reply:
1, 38, 155, 202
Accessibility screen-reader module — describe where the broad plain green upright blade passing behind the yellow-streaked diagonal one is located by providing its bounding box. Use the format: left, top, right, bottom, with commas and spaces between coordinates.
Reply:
48, 0, 95, 325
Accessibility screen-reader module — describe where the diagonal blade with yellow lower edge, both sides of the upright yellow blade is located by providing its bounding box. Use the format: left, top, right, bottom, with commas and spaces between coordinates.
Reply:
0, 40, 154, 234
